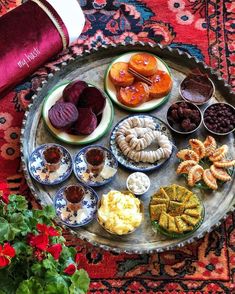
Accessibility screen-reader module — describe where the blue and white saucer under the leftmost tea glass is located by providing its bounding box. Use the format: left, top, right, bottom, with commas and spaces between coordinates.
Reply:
28, 143, 73, 185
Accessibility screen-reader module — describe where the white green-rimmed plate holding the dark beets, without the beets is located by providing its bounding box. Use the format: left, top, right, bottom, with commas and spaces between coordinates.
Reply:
42, 82, 113, 145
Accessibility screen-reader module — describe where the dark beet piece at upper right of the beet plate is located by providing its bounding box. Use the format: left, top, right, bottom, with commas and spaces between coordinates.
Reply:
78, 87, 106, 115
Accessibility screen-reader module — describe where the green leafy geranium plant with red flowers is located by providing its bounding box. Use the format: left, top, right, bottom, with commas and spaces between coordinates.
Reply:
0, 195, 89, 294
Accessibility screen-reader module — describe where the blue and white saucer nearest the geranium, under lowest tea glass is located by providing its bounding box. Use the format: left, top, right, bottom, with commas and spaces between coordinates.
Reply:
54, 184, 98, 228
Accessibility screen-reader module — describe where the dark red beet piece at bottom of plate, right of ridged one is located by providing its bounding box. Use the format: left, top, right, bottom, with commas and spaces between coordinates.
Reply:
76, 108, 97, 135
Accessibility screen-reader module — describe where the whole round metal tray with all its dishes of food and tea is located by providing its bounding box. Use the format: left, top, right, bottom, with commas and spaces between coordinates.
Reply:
21, 43, 235, 253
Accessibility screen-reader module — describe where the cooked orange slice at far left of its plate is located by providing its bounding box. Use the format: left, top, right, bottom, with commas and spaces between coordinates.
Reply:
109, 62, 135, 87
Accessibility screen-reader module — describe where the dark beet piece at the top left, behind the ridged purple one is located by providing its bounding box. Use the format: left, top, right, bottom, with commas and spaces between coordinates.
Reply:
63, 81, 88, 105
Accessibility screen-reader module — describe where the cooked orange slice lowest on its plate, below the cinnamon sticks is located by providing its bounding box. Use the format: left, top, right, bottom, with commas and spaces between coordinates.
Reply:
117, 82, 149, 107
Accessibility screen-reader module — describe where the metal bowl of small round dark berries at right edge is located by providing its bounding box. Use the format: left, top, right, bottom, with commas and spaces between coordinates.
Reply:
203, 102, 235, 135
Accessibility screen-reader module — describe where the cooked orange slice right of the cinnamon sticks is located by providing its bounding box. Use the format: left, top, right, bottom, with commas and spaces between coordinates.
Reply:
149, 70, 172, 99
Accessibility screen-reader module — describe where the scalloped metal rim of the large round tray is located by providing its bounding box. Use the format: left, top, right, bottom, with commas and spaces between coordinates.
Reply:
20, 41, 235, 254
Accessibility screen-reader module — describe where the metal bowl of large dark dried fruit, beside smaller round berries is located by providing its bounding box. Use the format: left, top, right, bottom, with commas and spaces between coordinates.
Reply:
167, 101, 202, 134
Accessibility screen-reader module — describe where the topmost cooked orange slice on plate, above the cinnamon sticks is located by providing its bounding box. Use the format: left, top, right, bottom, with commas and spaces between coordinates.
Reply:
129, 53, 157, 77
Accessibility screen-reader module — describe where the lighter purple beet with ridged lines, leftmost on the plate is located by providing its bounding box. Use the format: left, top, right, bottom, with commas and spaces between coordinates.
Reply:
48, 102, 78, 129
